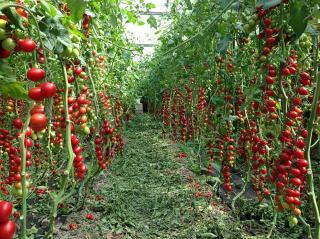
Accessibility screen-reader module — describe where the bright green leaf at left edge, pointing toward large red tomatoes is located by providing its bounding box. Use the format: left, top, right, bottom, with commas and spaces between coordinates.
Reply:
0, 82, 28, 100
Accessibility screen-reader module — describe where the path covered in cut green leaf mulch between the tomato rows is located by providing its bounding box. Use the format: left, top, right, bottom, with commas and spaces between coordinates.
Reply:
58, 114, 302, 239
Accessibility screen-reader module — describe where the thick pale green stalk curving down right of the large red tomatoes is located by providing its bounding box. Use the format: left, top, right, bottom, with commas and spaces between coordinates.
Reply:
48, 60, 74, 238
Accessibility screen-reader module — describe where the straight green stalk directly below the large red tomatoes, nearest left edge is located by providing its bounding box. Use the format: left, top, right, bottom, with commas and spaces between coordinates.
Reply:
19, 102, 32, 239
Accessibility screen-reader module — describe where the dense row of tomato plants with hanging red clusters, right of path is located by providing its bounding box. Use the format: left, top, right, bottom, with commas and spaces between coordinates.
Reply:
144, 0, 320, 239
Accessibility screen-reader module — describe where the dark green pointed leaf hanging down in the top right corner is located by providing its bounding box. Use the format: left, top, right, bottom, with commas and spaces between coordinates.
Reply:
289, 0, 310, 39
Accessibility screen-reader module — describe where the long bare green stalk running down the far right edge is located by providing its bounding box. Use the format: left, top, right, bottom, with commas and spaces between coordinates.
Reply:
304, 36, 320, 239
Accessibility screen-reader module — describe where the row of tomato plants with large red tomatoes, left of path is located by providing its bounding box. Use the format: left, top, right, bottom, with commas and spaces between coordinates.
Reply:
0, 0, 146, 239
